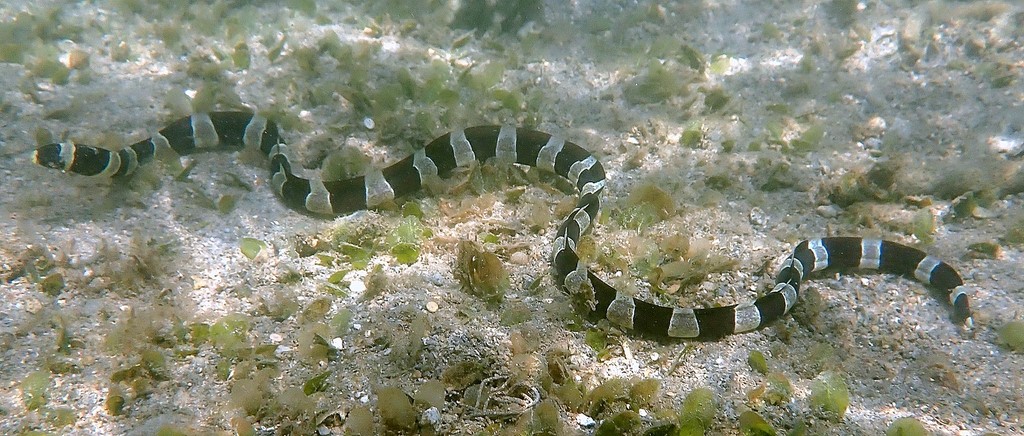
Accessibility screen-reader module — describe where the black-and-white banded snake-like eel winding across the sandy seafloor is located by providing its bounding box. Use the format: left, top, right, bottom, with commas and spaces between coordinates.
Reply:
34, 112, 972, 339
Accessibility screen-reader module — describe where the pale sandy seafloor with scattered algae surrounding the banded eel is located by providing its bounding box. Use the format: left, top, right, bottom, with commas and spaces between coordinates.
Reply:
0, 0, 1024, 435
